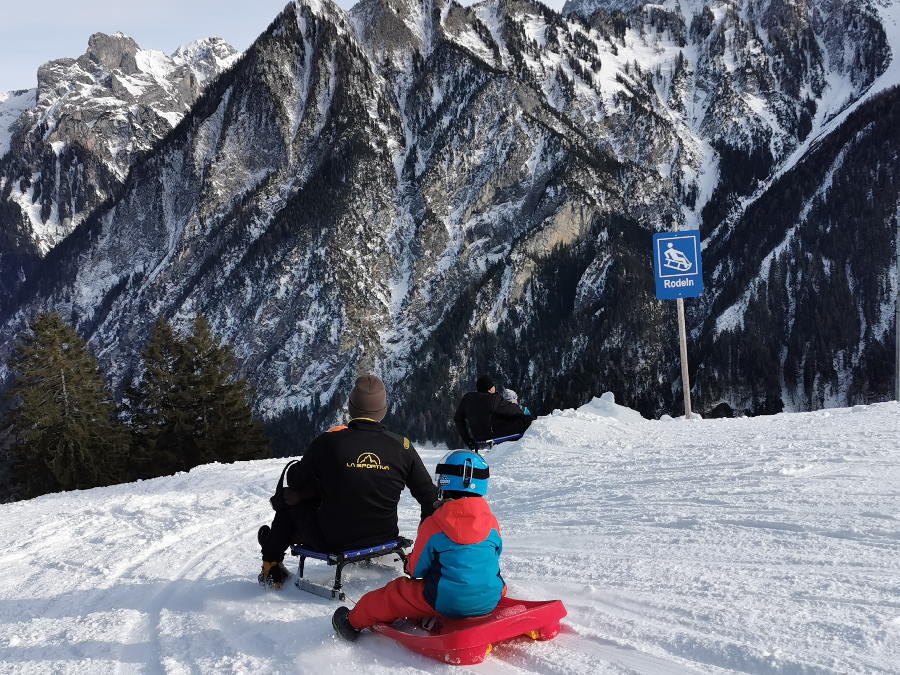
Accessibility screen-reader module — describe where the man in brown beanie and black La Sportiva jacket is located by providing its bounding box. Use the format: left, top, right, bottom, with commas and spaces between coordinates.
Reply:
258, 375, 438, 588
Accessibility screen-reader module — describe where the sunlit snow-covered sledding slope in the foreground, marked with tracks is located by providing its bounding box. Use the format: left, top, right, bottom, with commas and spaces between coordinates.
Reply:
0, 394, 900, 675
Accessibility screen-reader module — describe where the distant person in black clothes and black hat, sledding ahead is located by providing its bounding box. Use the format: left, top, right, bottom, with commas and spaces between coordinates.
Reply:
453, 375, 535, 450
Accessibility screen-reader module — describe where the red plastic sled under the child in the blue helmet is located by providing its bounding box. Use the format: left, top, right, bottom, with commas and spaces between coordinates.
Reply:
372, 598, 566, 666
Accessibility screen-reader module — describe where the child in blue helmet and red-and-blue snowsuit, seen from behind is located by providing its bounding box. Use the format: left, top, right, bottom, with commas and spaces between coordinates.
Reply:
332, 450, 506, 640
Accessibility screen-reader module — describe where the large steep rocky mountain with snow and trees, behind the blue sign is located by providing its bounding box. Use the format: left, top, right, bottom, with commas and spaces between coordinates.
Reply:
0, 0, 900, 442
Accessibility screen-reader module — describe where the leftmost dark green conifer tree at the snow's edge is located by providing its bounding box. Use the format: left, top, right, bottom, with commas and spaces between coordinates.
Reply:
2, 313, 128, 498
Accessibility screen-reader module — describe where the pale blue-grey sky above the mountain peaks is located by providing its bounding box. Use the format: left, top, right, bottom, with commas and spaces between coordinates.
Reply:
0, 0, 564, 92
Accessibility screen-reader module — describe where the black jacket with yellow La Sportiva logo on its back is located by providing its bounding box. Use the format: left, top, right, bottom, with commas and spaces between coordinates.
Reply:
287, 420, 437, 551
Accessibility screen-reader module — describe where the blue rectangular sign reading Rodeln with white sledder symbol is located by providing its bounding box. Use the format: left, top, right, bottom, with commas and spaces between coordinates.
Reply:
653, 230, 703, 300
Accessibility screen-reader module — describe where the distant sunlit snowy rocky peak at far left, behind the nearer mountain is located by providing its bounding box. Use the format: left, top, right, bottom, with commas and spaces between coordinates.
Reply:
0, 33, 237, 312
